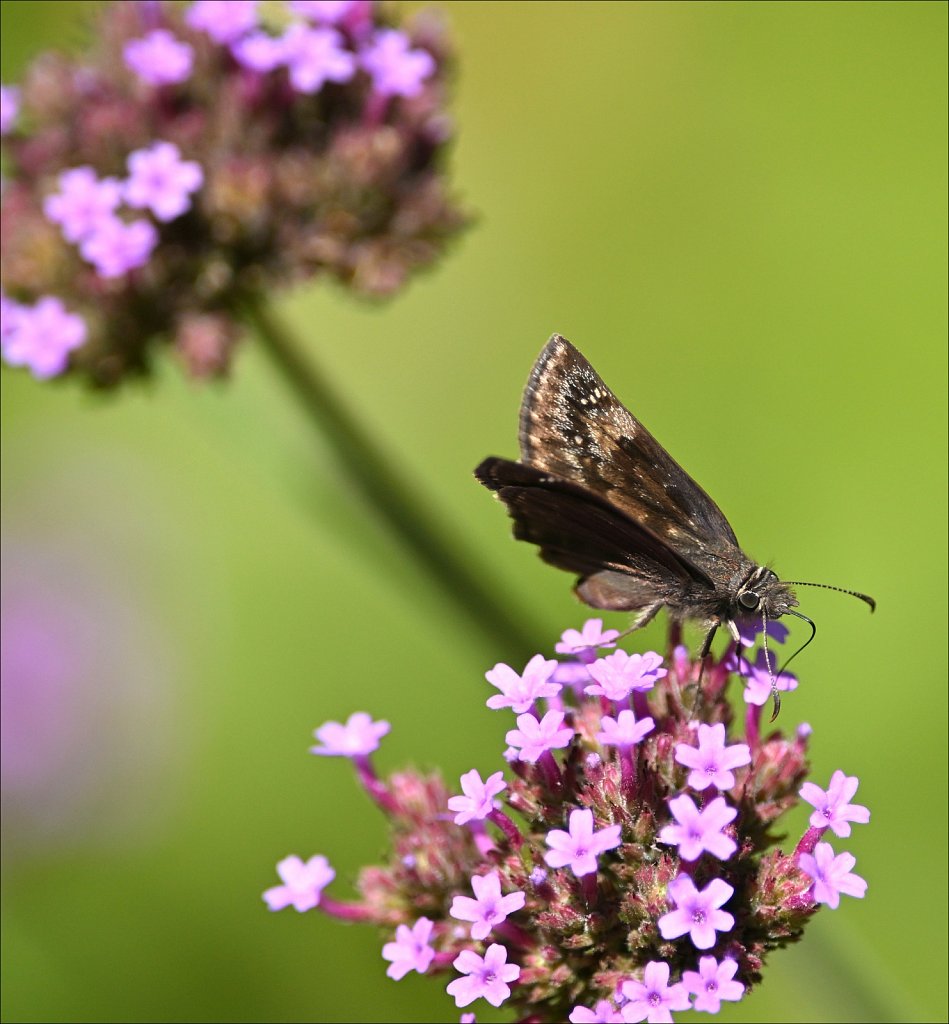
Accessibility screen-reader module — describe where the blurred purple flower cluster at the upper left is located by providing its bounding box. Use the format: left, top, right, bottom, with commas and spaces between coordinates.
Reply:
0, 0, 465, 386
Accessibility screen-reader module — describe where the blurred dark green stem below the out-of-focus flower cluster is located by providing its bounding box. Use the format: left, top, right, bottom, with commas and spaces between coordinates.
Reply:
244, 298, 544, 668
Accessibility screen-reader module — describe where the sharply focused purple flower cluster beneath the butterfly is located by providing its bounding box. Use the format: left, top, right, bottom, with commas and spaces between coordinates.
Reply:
264, 620, 869, 1024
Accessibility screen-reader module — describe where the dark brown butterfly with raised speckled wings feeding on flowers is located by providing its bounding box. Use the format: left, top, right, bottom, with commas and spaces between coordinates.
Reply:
475, 334, 874, 714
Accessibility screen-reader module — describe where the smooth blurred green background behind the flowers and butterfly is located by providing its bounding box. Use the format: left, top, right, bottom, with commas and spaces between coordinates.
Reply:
0, 2, 947, 1021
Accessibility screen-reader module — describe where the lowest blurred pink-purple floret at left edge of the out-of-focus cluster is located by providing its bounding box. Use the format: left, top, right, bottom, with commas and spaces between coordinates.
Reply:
0, 296, 86, 380
